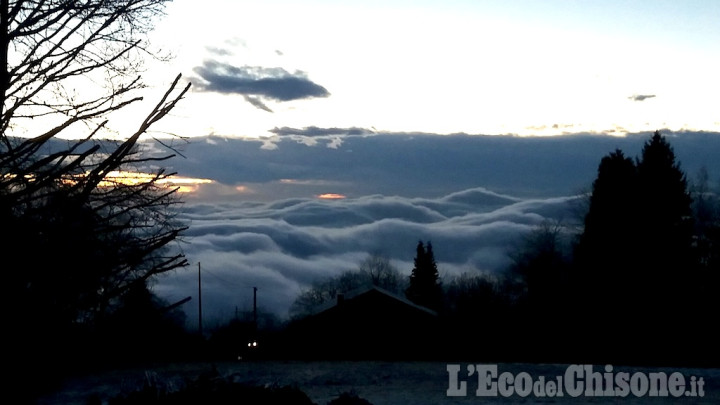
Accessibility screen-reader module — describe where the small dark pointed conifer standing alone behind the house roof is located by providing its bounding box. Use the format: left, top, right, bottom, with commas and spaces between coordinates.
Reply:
405, 241, 443, 311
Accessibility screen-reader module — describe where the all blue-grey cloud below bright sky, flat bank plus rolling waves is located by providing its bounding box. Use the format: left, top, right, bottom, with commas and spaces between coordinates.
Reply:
136, 132, 720, 321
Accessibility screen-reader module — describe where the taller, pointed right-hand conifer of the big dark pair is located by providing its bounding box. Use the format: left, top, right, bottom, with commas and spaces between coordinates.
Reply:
636, 132, 698, 357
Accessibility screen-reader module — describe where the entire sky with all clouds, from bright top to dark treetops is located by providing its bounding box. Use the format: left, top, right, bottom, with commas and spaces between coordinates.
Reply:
67, 0, 720, 323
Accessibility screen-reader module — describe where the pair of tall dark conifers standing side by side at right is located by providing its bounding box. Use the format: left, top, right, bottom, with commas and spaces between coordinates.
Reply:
575, 132, 697, 361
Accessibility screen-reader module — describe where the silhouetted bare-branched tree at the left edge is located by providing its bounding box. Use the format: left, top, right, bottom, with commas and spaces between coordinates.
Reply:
0, 0, 190, 388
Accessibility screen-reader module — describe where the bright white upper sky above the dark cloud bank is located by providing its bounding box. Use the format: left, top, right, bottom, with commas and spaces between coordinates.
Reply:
141, 0, 720, 137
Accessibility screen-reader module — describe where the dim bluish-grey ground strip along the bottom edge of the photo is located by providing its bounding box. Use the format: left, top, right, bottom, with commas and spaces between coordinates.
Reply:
39, 361, 720, 405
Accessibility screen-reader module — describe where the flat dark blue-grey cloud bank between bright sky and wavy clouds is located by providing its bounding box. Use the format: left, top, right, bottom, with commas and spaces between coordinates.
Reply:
170, 131, 720, 201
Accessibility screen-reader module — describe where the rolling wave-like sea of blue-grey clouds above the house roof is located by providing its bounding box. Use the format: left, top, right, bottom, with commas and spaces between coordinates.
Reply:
155, 188, 577, 320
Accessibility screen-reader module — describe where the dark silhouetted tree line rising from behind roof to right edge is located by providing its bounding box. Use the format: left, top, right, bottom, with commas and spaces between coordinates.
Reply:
286, 131, 720, 365
